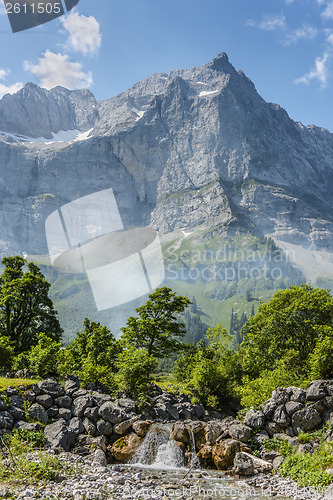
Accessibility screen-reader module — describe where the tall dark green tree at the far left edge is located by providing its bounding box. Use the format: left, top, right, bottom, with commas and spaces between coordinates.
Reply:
0, 256, 62, 353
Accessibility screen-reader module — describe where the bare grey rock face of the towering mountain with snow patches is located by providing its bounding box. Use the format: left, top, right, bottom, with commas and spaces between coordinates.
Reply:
0, 53, 333, 290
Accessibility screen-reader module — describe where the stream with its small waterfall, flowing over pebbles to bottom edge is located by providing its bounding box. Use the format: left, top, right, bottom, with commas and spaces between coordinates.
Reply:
128, 424, 285, 500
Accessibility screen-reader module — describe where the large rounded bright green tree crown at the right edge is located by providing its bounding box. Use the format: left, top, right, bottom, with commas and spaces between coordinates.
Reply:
241, 284, 333, 378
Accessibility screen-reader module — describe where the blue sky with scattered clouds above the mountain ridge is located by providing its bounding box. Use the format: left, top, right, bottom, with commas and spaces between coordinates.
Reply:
0, 0, 333, 132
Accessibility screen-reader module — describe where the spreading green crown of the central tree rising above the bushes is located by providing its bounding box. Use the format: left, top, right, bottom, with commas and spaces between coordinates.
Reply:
122, 287, 191, 358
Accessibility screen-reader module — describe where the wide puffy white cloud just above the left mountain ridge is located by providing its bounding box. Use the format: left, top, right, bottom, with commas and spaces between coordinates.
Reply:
24, 50, 93, 89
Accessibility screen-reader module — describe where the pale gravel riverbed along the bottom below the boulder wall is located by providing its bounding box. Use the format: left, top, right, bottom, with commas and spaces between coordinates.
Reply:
0, 453, 333, 500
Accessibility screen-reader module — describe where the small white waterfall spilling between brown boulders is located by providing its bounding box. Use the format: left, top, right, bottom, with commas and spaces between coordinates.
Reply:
131, 424, 184, 470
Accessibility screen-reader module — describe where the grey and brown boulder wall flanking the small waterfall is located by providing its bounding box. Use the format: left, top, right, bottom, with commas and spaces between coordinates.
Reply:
0, 378, 333, 476
